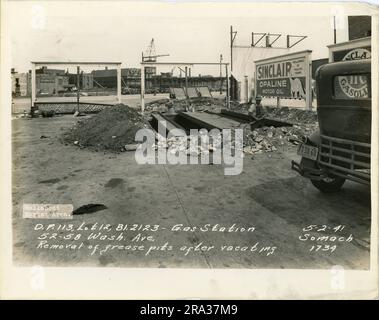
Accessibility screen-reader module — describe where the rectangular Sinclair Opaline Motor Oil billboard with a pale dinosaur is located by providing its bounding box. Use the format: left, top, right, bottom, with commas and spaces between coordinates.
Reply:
255, 51, 311, 108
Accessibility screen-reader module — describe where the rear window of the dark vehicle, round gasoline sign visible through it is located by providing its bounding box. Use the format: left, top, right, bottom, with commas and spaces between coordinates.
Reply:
333, 74, 371, 100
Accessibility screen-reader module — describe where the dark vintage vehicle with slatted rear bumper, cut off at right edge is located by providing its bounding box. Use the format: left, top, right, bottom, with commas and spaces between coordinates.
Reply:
291, 59, 372, 193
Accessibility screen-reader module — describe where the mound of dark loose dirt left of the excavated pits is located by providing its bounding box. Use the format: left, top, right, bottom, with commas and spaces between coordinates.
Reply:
63, 104, 147, 152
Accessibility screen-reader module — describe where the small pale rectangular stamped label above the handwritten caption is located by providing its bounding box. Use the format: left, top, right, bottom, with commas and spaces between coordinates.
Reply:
22, 203, 74, 219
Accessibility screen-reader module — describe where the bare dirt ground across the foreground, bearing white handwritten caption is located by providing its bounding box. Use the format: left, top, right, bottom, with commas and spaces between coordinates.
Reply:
12, 116, 371, 269
